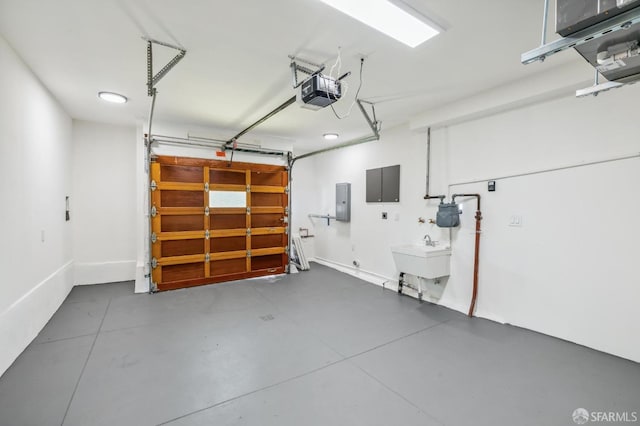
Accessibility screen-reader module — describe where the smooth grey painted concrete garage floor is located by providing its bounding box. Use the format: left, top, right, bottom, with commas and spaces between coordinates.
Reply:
0, 264, 640, 426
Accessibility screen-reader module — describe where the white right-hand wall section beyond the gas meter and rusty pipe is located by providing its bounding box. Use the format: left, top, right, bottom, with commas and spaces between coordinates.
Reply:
434, 86, 640, 361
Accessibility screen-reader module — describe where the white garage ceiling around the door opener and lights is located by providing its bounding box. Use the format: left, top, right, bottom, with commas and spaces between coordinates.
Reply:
0, 0, 577, 150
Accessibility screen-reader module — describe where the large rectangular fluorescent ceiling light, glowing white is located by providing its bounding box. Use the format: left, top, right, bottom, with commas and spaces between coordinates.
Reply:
321, 0, 442, 47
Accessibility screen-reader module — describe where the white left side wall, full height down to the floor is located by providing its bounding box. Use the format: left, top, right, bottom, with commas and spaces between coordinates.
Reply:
0, 37, 73, 374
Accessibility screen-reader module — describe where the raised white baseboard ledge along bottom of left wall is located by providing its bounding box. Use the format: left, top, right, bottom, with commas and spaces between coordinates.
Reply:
0, 261, 73, 375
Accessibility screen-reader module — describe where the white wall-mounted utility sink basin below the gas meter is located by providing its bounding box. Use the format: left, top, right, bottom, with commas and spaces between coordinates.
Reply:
391, 243, 451, 279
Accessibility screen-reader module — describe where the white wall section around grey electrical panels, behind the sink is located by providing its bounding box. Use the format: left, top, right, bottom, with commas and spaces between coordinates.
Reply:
293, 126, 440, 283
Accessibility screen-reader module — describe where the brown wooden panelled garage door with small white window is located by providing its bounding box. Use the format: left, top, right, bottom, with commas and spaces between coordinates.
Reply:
150, 157, 288, 290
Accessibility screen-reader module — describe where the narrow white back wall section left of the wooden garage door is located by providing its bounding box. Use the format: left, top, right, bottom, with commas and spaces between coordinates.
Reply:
71, 120, 137, 285
